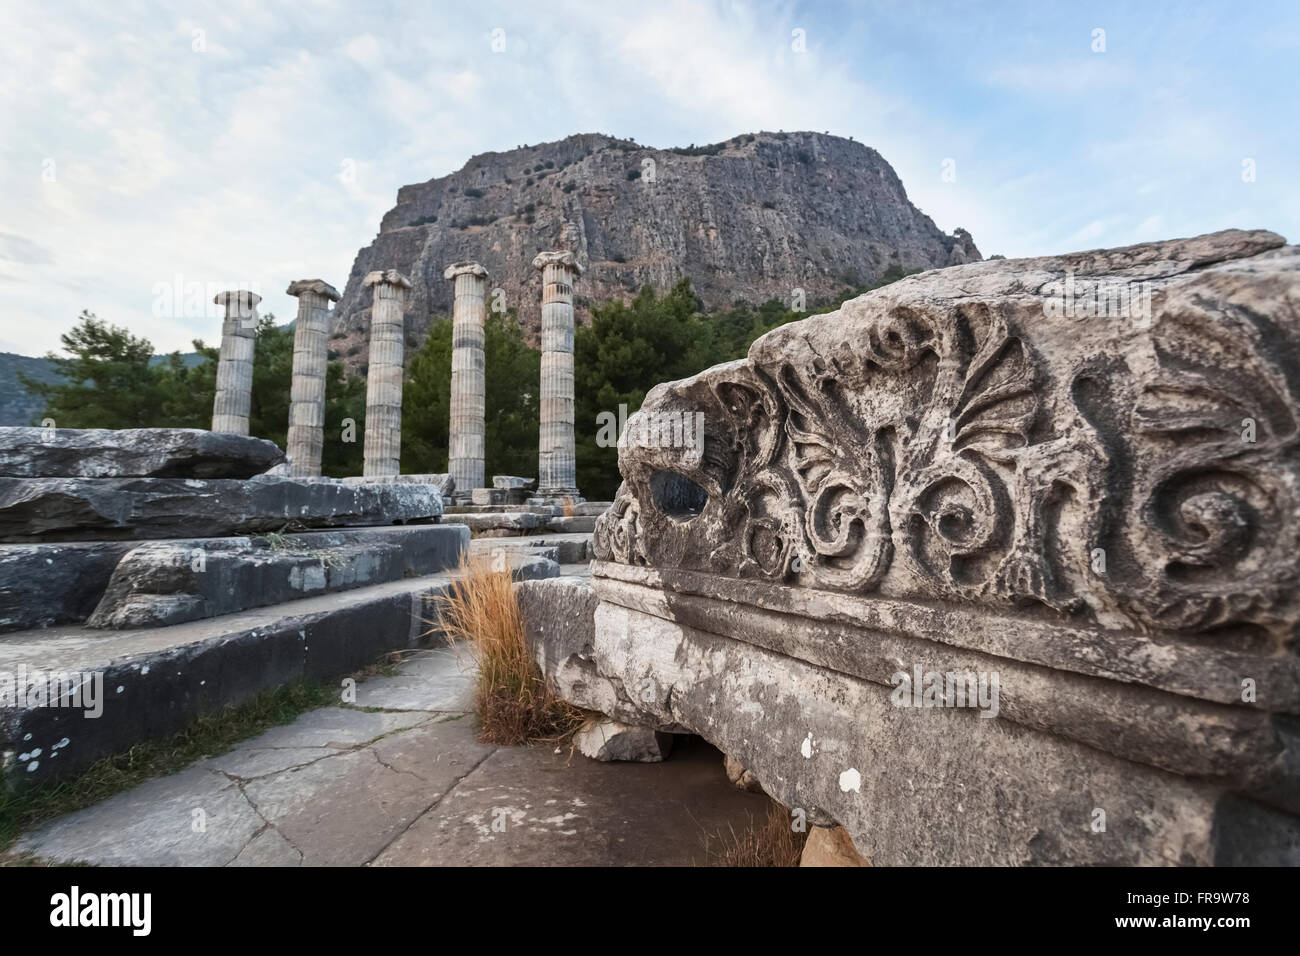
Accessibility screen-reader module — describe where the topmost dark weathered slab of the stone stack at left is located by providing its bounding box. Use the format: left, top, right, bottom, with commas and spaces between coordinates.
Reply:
0, 428, 285, 479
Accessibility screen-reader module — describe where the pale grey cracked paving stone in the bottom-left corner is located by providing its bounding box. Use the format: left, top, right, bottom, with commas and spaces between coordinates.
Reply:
14, 767, 265, 866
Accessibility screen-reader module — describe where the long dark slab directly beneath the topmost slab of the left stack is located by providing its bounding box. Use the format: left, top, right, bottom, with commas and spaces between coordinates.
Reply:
0, 477, 442, 541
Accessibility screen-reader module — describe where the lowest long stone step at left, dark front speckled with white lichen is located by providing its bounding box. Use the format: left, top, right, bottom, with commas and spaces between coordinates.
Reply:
0, 553, 559, 787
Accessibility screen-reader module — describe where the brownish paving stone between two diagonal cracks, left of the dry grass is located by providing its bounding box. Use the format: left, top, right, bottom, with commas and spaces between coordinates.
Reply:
244, 721, 493, 866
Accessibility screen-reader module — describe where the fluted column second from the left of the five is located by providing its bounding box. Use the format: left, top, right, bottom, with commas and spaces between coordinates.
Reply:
285, 278, 338, 477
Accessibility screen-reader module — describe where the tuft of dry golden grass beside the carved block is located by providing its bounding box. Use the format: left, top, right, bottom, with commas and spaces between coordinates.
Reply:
438, 554, 585, 747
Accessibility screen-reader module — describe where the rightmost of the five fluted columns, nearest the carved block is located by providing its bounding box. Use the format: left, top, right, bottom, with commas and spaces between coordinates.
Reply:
533, 252, 582, 498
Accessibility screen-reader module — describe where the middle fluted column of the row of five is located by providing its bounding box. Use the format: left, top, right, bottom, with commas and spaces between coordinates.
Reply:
361, 269, 411, 477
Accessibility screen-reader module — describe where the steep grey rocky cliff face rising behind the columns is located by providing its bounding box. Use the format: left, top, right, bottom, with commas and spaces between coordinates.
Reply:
332, 133, 980, 365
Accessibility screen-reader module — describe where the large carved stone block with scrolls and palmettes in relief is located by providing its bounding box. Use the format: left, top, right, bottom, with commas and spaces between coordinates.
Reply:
566, 230, 1300, 865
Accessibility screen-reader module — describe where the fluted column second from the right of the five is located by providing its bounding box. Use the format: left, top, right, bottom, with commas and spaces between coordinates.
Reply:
442, 263, 488, 498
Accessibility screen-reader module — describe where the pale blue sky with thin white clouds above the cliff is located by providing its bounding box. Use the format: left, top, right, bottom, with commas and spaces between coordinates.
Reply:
0, 0, 1300, 355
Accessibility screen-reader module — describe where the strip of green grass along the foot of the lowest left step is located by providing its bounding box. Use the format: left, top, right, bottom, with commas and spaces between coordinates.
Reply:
0, 682, 341, 862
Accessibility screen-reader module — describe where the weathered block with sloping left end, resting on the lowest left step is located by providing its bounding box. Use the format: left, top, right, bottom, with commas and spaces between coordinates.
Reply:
86, 524, 469, 630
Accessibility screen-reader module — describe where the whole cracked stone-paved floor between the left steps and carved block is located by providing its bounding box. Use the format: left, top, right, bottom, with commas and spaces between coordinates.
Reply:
10, 648, 767, 866
